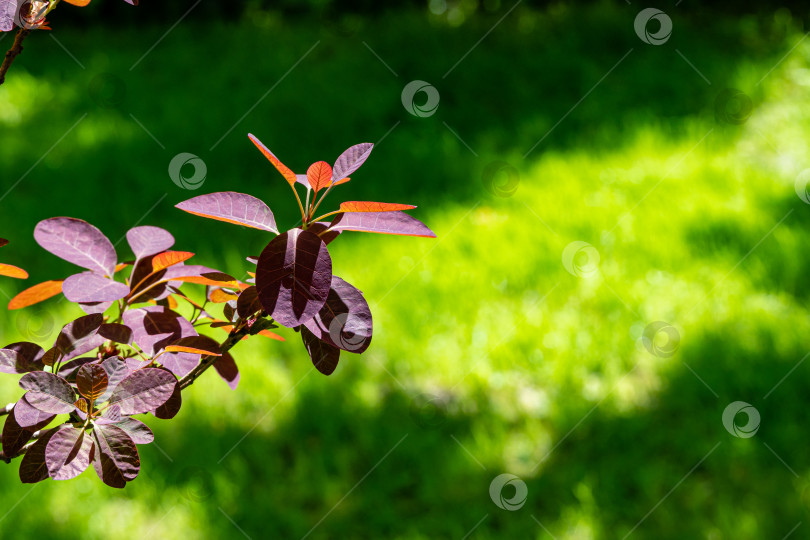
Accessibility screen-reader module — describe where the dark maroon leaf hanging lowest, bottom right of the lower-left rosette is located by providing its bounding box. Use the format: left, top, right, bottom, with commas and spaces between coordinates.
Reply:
93, 424, 141, 488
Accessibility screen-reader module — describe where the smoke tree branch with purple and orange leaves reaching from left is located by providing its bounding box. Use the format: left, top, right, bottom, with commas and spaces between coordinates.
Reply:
0, 135, 435, 488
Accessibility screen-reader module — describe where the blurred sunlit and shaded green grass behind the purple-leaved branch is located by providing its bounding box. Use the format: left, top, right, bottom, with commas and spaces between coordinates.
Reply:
0, 4, 810, 539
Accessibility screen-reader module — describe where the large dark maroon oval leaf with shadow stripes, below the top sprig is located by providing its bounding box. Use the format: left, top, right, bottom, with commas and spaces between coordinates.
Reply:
256, 229, 332, 328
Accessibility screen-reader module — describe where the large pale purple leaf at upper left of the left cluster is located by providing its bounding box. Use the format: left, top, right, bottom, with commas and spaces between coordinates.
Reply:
34, 217, 117, 276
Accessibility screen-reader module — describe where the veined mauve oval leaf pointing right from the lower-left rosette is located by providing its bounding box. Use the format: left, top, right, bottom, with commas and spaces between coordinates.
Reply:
110, 368, 177, 415
